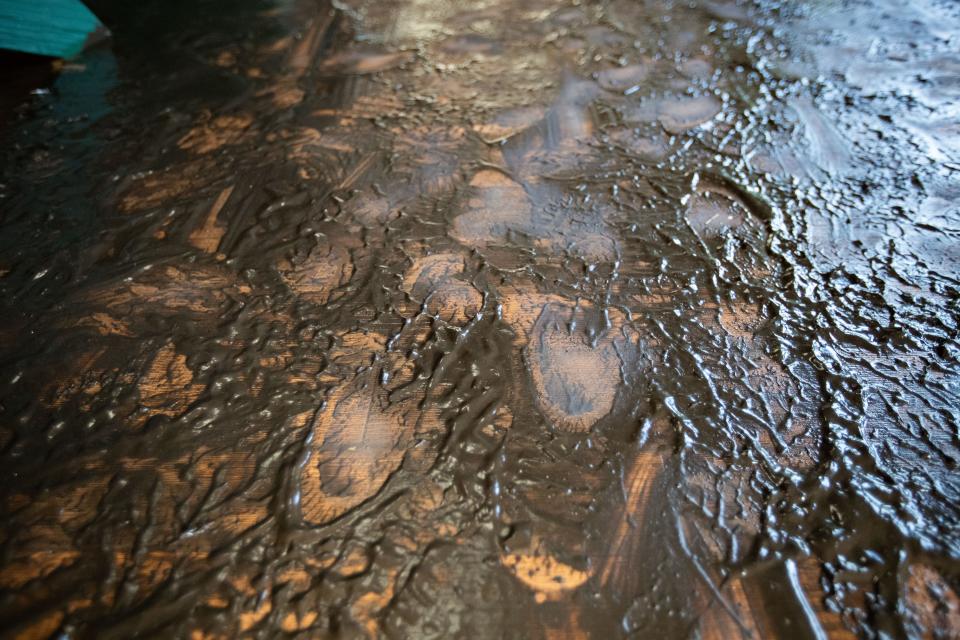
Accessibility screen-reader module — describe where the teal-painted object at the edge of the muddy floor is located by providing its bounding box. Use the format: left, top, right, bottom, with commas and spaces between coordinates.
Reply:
0, 0, 110, 58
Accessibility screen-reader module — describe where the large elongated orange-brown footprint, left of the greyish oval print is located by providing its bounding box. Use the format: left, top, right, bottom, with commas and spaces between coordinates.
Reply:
298, 308, 445, 526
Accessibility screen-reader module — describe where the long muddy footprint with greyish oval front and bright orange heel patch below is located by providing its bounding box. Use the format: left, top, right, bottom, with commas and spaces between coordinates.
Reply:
498, 284, 648, 603
